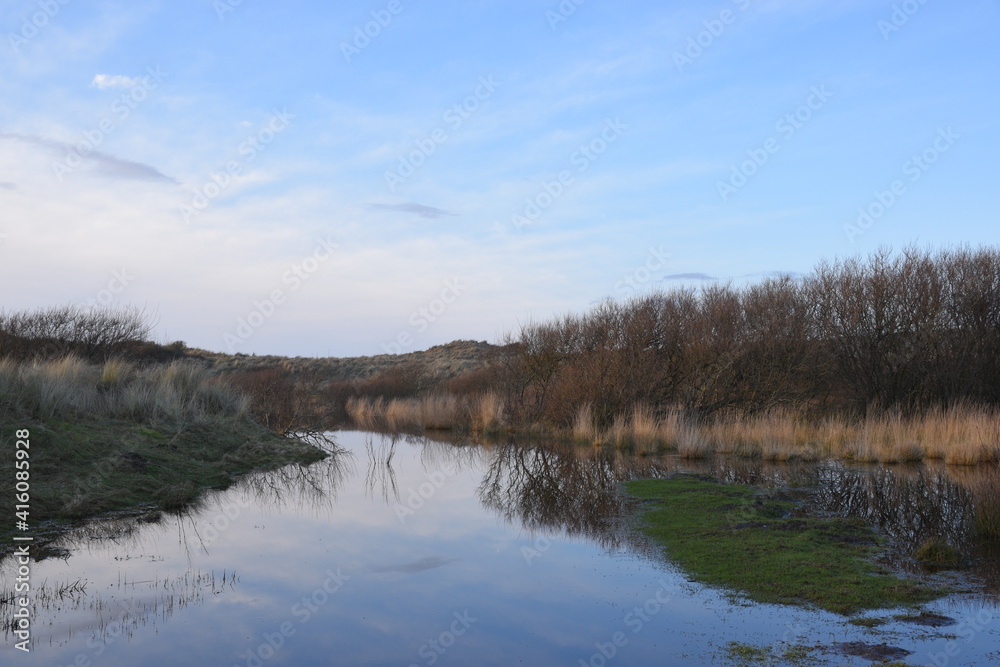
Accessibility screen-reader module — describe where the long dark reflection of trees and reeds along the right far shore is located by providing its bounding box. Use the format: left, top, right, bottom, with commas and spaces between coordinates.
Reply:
478, 442, 1000, 598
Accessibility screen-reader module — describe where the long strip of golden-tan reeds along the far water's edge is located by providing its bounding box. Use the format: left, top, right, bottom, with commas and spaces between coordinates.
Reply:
347, 393, 1000, 465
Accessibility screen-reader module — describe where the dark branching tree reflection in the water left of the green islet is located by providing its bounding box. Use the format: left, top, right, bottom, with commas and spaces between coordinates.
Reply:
478, 442, 669, 549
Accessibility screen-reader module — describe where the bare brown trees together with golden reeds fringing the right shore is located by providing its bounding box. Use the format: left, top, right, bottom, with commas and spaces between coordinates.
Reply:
344, 248, 1000, 465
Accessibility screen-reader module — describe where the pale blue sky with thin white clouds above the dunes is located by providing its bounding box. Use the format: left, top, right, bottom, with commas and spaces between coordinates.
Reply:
0, 0, 1000, 356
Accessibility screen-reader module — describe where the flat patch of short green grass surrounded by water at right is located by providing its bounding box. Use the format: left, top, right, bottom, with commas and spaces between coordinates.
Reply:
625, 475, 945, 614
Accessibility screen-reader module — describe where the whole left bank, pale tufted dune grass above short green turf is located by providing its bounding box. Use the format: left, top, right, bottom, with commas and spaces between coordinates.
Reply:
0, 357, 325, 545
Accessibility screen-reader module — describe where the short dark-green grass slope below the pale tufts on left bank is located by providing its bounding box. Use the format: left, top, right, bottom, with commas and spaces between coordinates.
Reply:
0, 418, 325, 549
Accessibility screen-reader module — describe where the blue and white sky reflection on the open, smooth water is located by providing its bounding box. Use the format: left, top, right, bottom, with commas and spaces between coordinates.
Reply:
0, 433, 1000, 667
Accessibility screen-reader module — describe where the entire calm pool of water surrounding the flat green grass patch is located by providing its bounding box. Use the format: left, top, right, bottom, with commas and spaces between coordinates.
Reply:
0, 432, 1000, 667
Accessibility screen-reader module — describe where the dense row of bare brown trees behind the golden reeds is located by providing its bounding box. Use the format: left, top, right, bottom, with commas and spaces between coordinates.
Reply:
493, 248, 1000, 426
